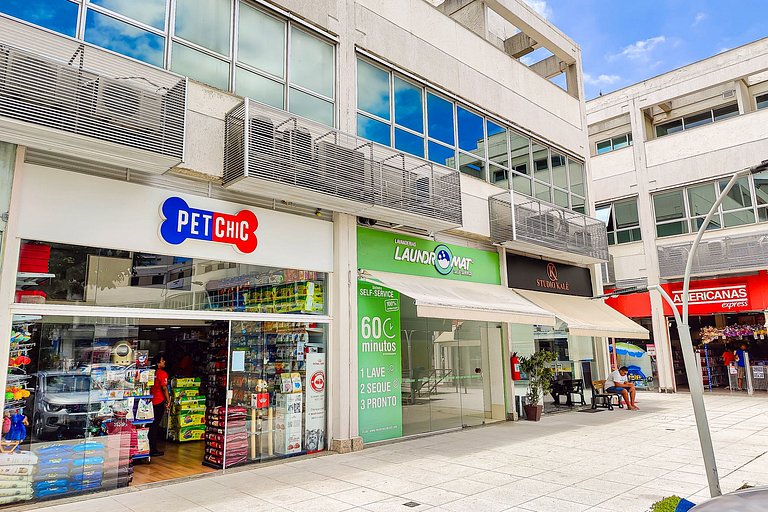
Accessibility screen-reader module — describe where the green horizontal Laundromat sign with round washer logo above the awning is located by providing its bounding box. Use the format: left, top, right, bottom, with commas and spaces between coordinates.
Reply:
357, 228, 501, 284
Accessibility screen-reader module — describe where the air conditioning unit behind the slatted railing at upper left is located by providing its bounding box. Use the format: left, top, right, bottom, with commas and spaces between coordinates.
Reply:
94, 77, 163, 132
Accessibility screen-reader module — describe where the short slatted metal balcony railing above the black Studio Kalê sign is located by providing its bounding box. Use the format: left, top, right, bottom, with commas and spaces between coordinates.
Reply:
488, 190, 608, 263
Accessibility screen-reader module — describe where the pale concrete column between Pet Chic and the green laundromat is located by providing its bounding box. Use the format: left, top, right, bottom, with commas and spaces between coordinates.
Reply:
328, 213, 363, 453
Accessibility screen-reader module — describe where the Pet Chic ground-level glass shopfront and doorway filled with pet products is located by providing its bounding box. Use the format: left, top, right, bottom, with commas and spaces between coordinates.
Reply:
6, 315, 325, 504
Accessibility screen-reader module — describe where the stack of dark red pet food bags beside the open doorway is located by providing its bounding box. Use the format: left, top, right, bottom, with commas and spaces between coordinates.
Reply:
203, 406, 248, 469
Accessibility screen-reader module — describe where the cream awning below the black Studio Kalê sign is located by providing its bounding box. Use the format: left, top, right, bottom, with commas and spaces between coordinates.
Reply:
515, 290, 649, 340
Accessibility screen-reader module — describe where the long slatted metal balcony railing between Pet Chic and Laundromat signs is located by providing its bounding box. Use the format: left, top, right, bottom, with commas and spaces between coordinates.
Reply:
224, 99, 462, 230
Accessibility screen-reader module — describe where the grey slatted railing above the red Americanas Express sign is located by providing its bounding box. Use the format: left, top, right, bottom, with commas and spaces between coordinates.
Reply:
657, 231, 768, 279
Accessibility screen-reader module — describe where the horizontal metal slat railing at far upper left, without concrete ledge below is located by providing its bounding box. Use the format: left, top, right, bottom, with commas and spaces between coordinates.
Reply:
0, 37, 187, 167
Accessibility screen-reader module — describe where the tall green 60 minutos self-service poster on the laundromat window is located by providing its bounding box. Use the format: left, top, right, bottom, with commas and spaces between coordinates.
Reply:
357, 281, 403, 443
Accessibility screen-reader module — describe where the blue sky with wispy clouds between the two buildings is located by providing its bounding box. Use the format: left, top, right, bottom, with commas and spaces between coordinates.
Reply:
526, 0, 768, 100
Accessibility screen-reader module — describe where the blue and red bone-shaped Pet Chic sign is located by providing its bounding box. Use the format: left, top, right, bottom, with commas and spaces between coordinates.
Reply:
160, 197, 259, 254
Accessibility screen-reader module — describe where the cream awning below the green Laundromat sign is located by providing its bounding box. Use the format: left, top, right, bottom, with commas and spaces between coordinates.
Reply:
361, 270, 555, 326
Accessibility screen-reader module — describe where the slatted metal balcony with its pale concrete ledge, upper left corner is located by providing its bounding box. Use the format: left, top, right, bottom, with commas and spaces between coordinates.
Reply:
0, 19, 186, 173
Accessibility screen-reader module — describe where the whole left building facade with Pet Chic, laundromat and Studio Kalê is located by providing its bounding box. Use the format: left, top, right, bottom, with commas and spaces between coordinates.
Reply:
0, 0, 648, 503
